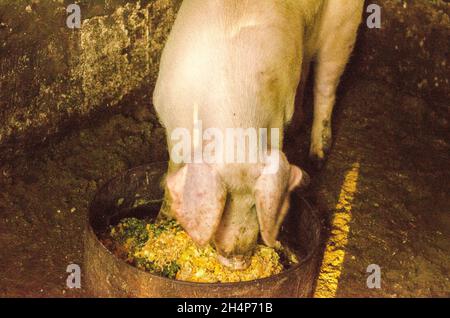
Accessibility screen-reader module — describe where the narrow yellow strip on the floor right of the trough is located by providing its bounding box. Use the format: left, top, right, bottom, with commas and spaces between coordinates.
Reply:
314, 162, 360, 298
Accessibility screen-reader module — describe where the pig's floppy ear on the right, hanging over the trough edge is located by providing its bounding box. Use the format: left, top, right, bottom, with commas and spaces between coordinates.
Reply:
254, 160, 304, 247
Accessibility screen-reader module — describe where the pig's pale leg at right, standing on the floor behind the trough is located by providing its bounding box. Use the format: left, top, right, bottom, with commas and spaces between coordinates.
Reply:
309, 4, 362, 168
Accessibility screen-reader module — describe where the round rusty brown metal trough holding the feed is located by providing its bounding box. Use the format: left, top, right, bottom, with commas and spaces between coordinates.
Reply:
84, 163, 322, 298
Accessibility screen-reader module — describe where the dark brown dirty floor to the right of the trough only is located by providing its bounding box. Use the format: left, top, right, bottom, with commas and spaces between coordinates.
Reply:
288, 80, 450, 297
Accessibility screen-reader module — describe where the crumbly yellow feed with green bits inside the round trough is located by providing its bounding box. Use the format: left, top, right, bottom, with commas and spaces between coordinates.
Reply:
109, 218, 298, 283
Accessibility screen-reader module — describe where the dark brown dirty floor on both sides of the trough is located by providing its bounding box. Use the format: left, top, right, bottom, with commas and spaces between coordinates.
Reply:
0, 79, 450, 297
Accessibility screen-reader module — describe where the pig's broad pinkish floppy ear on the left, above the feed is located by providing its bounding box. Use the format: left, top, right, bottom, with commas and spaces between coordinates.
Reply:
167, 164, 227, 245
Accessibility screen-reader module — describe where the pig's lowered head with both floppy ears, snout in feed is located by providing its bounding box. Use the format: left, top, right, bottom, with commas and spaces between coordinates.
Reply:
167, 151, 309, 269
